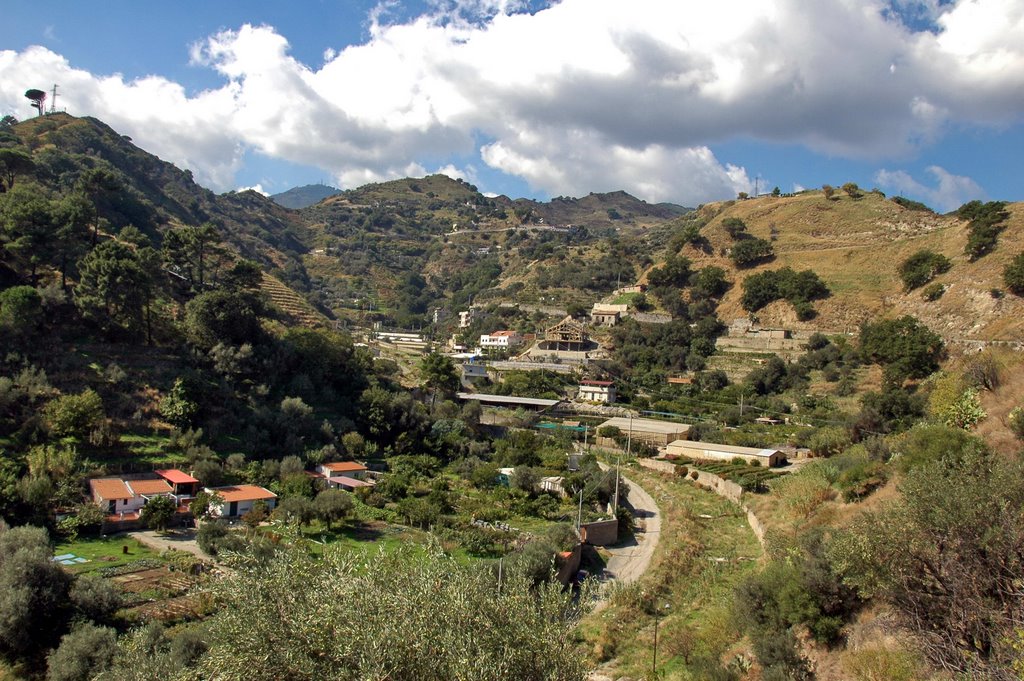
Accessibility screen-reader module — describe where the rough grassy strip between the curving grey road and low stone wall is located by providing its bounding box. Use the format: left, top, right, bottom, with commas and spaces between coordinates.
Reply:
581, 469, 762, 679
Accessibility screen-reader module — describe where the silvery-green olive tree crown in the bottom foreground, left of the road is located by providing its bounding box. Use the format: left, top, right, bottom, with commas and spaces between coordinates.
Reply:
198, 547, 587, 681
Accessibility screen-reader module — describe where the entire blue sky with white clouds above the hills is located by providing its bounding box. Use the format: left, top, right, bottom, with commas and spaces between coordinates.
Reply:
0, 0, 1024, 211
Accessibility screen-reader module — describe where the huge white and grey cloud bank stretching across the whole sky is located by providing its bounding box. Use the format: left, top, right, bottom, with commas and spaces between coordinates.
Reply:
0, 0, 1024, 204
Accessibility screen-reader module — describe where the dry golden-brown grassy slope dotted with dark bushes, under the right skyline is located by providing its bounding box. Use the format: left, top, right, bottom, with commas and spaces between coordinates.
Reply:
667, 191, 1024, 340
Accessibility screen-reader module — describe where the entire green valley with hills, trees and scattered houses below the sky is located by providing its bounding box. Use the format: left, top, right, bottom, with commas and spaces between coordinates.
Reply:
0, 114, 1024, 681
